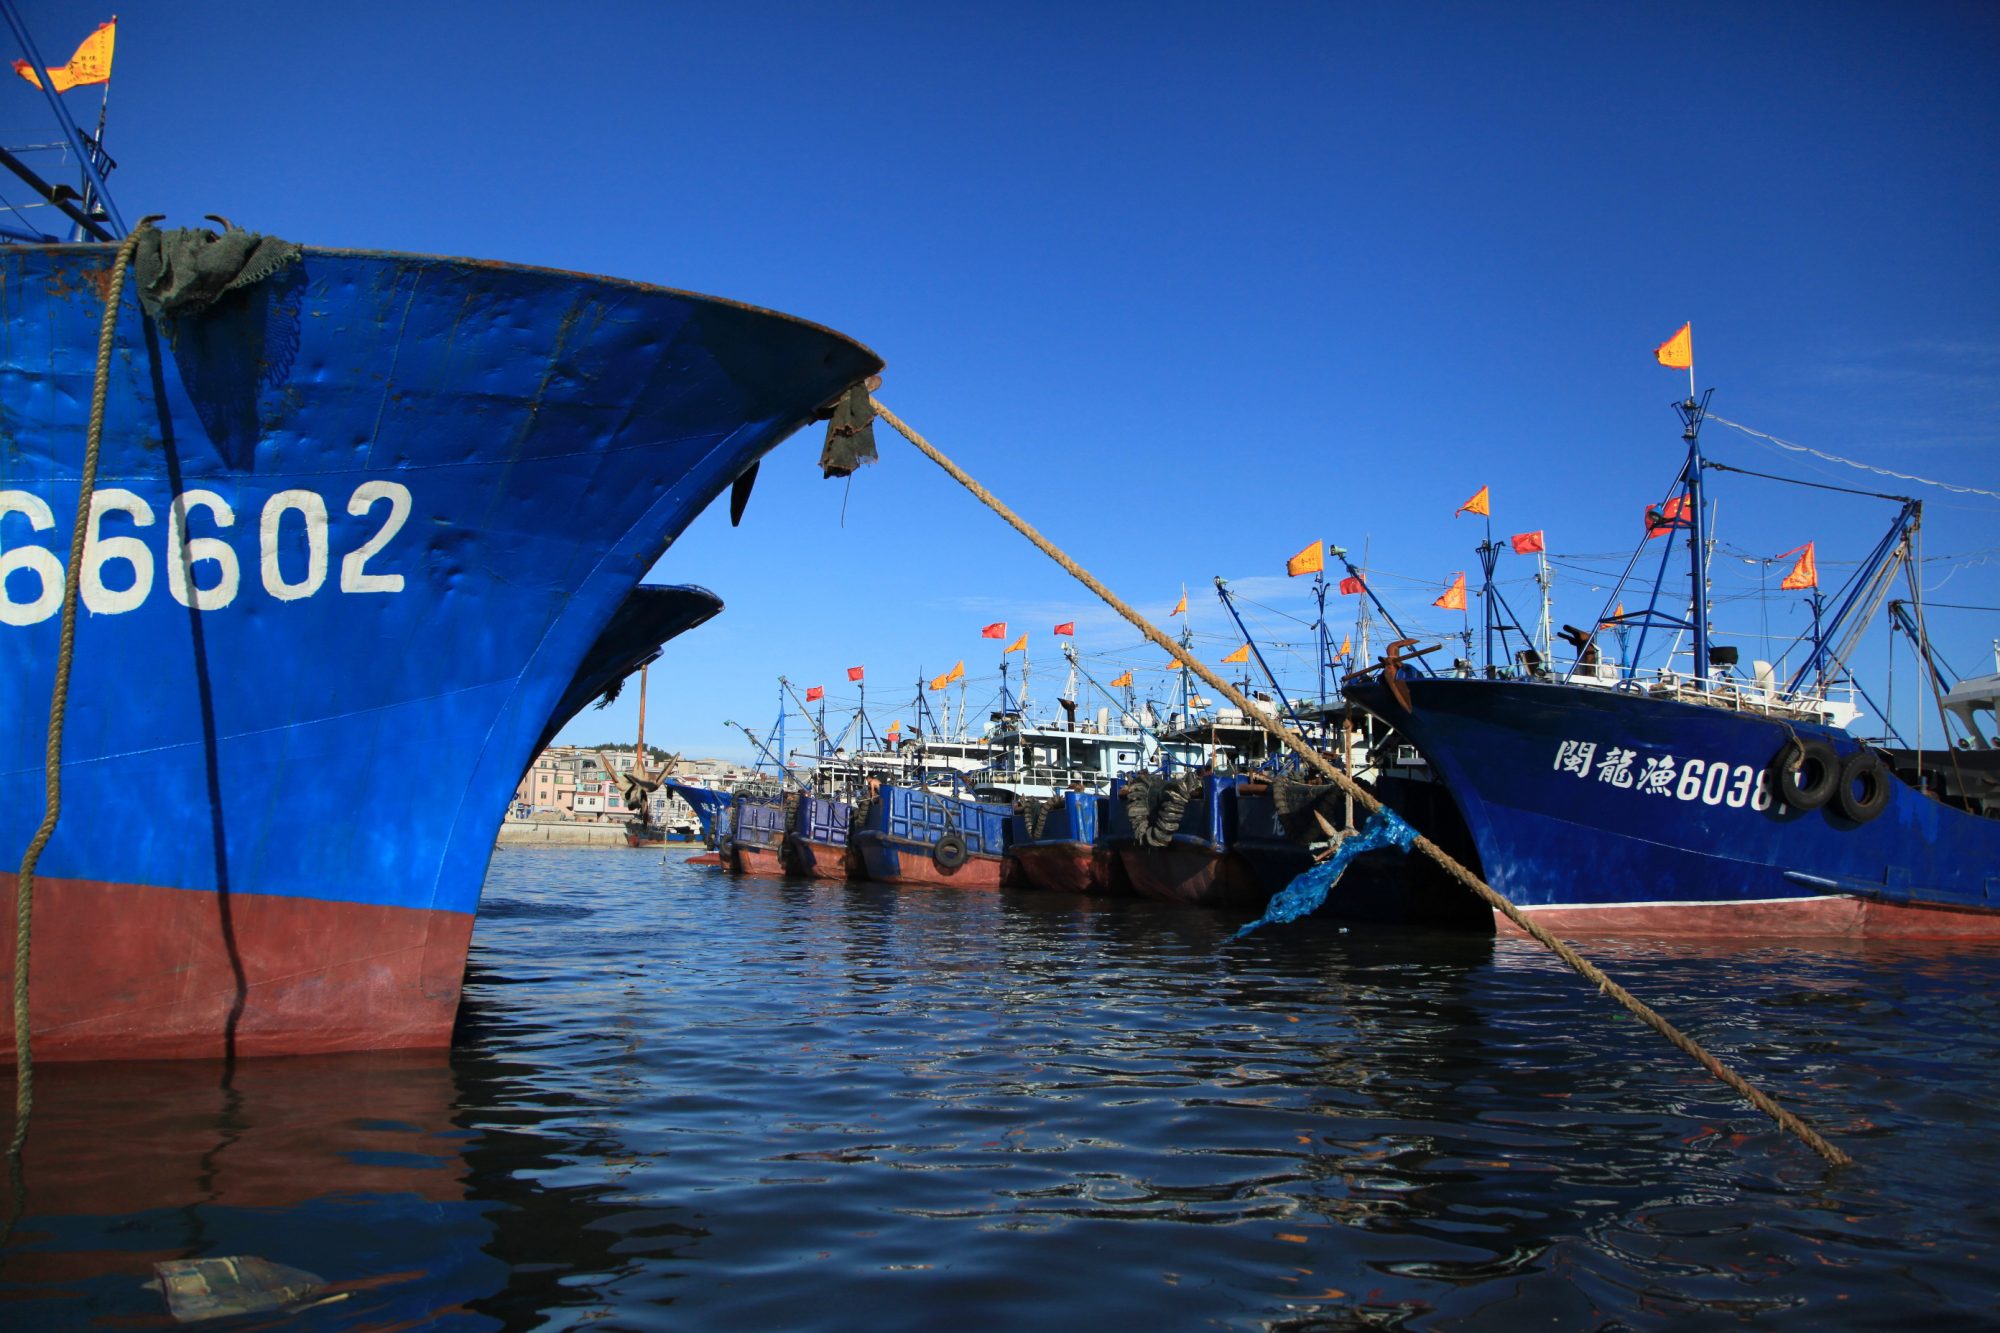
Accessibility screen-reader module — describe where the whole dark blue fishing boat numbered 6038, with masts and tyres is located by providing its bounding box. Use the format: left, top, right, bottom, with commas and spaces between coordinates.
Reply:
1348, 396, 2000, 939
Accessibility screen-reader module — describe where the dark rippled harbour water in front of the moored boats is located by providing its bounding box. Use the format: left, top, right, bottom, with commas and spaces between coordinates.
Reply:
0, 847, 2000, 1333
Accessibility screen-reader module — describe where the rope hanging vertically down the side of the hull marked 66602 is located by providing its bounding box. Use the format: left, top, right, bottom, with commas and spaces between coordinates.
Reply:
8, 218, 154, 1157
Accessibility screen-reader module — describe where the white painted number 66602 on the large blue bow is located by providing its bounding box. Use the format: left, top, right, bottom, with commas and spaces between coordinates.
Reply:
0, 480, 410, 624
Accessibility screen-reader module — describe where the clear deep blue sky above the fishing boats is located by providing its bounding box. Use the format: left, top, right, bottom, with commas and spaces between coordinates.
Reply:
0, 0, 2000, 757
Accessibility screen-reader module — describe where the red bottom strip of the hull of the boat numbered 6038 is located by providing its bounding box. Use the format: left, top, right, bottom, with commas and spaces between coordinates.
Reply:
1494, 895, 2000, 941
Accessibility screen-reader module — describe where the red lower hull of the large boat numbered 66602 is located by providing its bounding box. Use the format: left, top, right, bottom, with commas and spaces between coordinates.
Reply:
0, 873, 472, 1061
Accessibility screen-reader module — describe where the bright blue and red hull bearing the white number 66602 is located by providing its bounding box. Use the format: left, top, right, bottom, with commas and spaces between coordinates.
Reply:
0, 236, 880, 1059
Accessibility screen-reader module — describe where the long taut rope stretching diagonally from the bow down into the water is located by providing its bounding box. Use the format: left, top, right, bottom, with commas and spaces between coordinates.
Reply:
874, 400, 1854, 1167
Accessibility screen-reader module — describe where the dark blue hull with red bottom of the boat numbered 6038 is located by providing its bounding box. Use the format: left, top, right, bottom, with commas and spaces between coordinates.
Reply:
1348, 679, 2000, 939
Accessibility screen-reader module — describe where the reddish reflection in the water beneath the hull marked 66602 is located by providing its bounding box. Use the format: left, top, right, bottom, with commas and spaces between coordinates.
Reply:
0, 1055, 506, 1329
